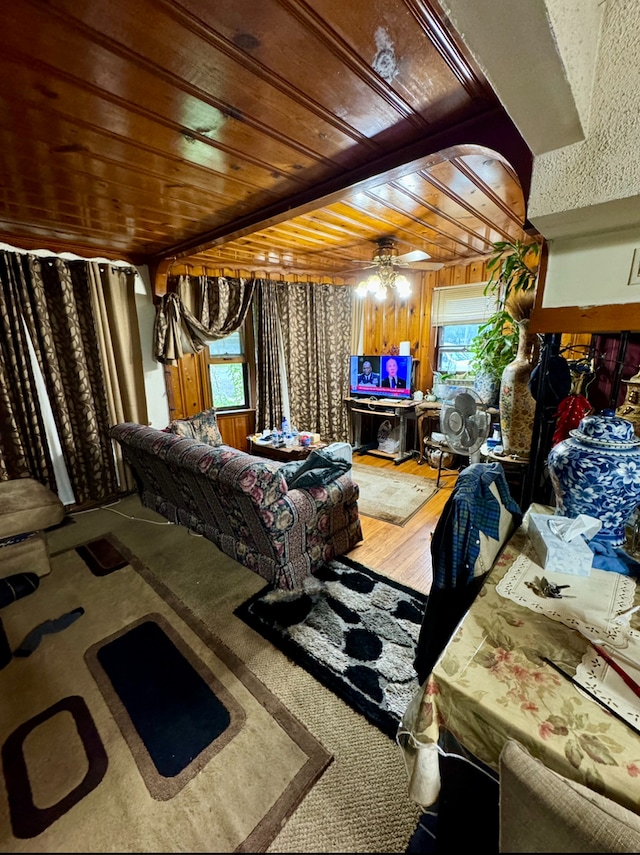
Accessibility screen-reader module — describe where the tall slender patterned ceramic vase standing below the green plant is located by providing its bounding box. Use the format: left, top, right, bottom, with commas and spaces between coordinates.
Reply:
499, 318, 536, 458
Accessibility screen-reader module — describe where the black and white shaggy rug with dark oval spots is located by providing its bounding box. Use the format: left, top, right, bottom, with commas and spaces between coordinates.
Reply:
235, 558, 427, 739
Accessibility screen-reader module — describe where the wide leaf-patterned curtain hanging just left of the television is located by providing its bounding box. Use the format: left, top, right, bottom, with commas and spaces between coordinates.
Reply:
276, 282, 353, 441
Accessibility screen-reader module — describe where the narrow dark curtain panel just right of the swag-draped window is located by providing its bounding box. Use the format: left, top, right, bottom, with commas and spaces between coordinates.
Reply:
253, 279, 283, 432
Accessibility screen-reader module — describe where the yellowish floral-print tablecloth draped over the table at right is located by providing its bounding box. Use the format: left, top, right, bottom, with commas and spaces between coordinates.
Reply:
397, 506, 640, 813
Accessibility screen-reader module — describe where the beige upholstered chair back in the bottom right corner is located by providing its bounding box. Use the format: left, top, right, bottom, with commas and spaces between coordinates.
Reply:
500, 739, 640, 852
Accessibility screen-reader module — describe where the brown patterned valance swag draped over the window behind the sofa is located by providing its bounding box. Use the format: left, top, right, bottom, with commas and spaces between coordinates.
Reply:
154, 276, 255, 364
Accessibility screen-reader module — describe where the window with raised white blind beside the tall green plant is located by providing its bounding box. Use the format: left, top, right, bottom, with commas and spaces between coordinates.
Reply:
431, 282, 497, 374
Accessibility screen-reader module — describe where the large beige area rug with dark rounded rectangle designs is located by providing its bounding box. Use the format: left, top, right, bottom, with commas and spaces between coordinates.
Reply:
0, 533, 331, 852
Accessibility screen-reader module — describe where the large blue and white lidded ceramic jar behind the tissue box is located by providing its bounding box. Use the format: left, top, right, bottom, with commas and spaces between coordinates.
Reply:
547, 410, 640, 546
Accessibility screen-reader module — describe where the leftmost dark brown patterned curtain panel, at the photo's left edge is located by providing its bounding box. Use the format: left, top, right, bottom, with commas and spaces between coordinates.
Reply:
0, 252, 56, 484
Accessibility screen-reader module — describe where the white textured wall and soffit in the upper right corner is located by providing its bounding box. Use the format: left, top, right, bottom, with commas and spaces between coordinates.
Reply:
441, 0, 640, 308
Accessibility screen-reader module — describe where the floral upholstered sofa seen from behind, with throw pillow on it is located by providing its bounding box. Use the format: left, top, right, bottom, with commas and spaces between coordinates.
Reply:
110, 411, 362, 589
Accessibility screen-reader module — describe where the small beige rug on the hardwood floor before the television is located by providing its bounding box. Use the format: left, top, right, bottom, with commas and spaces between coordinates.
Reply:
352, 463, 438, 526
